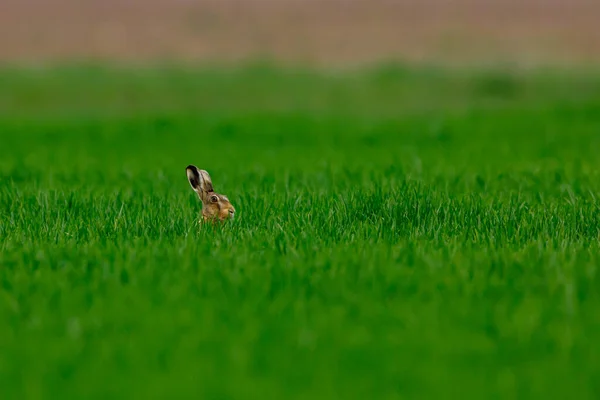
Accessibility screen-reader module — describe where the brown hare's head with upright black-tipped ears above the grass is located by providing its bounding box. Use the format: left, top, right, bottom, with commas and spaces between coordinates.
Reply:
185, 165, 235, 221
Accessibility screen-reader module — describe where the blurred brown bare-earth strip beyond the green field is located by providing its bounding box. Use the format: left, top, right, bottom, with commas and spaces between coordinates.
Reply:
0, 0, 600, 67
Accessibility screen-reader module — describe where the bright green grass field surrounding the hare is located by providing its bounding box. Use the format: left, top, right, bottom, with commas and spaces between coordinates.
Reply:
0, 65, 600, 399
